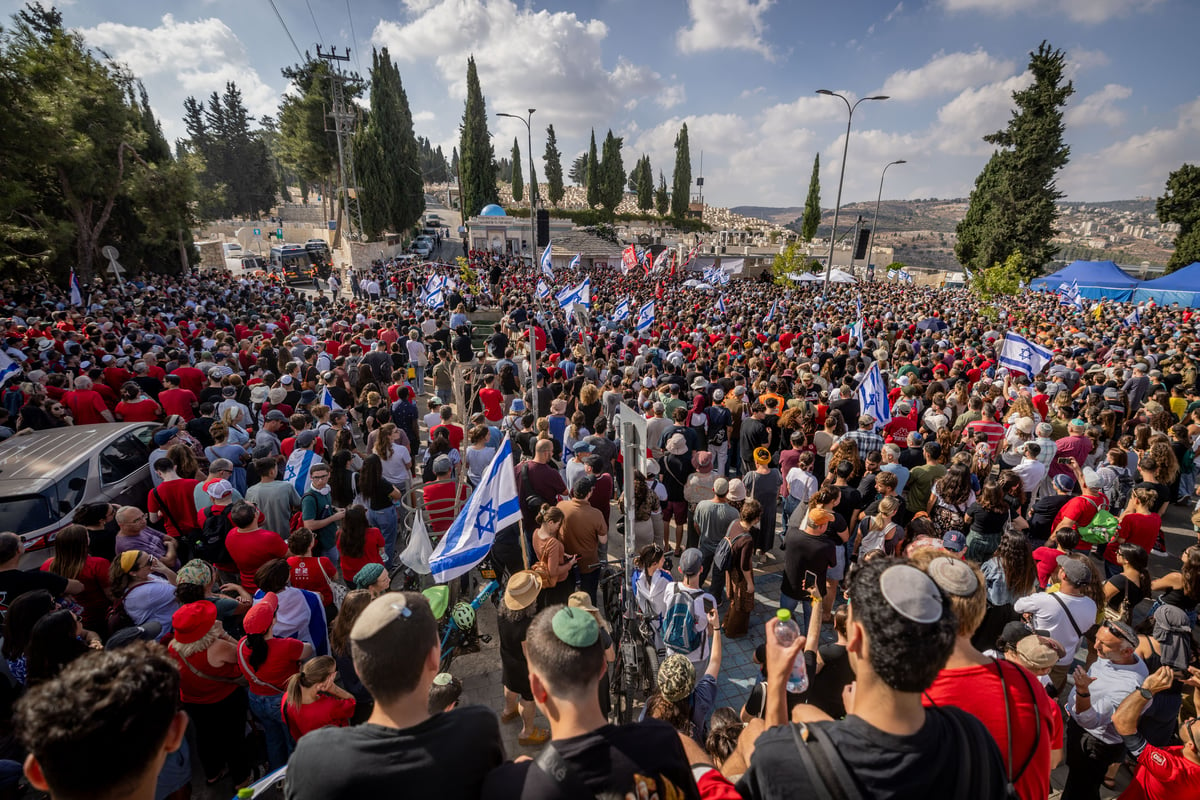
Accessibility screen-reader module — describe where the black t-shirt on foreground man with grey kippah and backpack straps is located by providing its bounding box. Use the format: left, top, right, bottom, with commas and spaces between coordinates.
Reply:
737, 708, 1007, 800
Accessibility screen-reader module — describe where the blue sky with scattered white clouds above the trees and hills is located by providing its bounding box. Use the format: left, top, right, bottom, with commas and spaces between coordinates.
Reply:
21, 0, 1200, 207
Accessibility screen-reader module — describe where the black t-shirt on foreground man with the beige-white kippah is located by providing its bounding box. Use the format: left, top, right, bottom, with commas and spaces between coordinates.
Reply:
283, 705, 504, 800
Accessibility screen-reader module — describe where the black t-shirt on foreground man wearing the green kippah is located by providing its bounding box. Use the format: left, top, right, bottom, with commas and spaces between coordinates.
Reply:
480, 720, 700, 800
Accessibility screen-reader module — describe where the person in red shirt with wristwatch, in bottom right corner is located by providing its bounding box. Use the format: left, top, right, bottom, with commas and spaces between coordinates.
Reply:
1112, 667, 1200, 800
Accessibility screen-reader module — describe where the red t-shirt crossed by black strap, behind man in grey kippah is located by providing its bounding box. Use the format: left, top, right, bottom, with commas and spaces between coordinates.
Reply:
922, 661, 1062, 800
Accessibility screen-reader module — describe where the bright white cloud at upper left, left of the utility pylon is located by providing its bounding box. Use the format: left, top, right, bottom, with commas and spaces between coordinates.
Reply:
79, 14, 283, 142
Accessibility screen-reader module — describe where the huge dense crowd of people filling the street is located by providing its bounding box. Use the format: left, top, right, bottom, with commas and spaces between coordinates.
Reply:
0, 245, 1200, 800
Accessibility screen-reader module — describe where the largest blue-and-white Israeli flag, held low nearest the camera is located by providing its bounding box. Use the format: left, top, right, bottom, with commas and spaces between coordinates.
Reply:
430, 437, 521, 583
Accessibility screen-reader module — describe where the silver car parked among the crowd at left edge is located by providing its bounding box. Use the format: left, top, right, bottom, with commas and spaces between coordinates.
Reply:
0, 422, 161, 569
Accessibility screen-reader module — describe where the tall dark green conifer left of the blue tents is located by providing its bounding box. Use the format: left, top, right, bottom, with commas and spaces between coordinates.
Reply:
954, 42, 1075, 279
